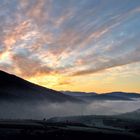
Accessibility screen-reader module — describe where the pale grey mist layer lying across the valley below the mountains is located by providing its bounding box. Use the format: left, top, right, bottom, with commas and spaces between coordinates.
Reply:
0, 99, 140, 119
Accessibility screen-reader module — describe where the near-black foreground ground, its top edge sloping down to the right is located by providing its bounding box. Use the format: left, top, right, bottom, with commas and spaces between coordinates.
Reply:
0, 120, 140, 140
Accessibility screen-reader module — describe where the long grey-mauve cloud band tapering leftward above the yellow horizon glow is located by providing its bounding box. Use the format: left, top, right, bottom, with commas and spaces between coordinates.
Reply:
73, 47, 140, 76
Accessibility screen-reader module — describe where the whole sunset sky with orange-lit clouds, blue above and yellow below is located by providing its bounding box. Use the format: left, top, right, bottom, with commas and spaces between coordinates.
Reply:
0, 0, 140, 93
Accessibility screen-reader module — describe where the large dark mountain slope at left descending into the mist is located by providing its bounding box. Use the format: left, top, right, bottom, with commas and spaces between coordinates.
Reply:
0, 71, 80, 102
